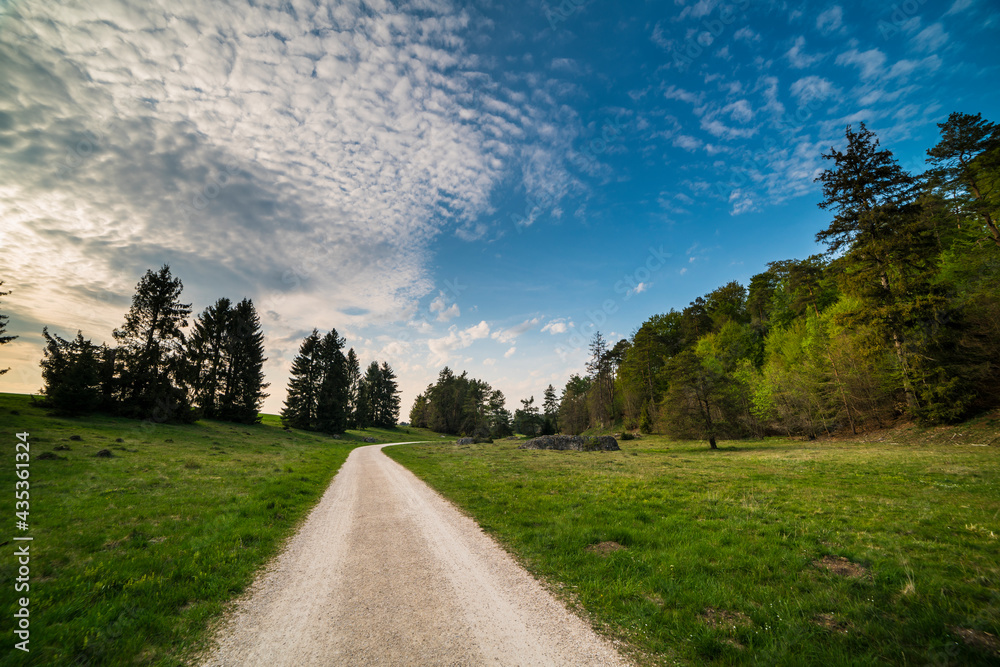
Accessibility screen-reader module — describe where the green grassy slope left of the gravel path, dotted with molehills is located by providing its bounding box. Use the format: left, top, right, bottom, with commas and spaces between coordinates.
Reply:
0, 394, 437, 666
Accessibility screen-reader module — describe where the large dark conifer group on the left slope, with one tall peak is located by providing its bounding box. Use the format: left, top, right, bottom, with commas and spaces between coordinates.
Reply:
41, 265, 268, 424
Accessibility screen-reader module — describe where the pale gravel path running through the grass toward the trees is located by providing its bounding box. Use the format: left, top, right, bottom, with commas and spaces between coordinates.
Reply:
201, 443, 630, 667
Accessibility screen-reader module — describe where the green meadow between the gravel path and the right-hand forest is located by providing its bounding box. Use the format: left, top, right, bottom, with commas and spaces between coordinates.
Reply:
386, 419, 1000, 665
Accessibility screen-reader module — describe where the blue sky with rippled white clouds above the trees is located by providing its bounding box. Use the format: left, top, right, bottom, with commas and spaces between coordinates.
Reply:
0, 0, 1000, 420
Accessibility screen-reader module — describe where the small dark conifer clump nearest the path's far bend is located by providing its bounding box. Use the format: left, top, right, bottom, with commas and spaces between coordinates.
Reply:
281, 329, 399, 433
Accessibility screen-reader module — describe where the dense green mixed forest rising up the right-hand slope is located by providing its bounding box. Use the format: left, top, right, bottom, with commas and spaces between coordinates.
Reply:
558, 113, 1000, 447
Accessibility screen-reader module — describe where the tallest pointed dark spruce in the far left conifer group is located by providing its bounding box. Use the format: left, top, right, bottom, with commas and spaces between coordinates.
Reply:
114, 264, 193, 421
